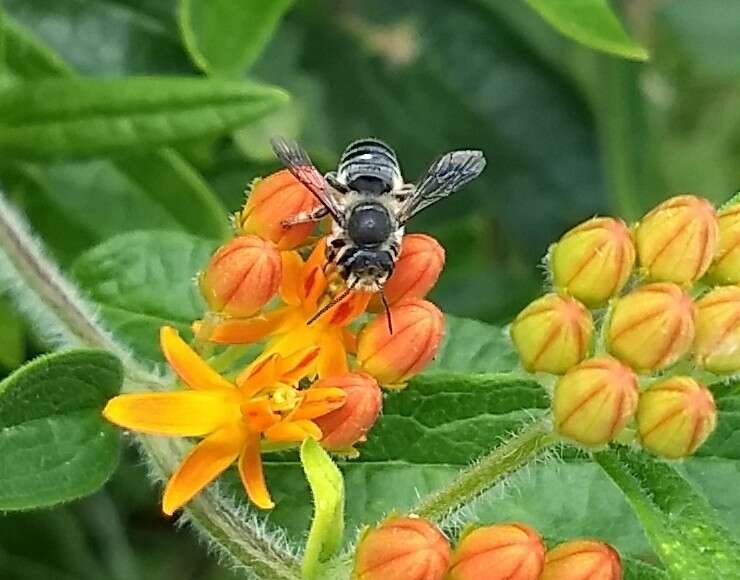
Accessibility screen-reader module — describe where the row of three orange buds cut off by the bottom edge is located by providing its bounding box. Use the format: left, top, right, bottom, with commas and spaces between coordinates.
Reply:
352, 516, 622, 580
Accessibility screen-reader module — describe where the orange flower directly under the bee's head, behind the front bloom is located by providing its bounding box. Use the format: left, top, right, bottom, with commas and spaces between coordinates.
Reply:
202, 241, 371, 377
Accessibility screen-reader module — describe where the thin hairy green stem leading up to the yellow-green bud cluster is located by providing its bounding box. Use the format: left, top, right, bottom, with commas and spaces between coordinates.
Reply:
410, 419, 559, 520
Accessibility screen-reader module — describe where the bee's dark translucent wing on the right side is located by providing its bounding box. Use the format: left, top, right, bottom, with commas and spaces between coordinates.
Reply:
399, 151, 486, 223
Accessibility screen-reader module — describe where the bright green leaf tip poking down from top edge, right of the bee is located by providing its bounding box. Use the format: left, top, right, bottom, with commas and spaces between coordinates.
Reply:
525, 0, 649, 60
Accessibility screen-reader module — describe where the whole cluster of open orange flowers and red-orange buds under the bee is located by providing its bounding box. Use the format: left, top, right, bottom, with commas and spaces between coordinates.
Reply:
103, 171, 444, 514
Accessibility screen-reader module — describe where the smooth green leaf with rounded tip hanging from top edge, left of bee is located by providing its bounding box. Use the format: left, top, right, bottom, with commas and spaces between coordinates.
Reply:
178, 0, 294, 77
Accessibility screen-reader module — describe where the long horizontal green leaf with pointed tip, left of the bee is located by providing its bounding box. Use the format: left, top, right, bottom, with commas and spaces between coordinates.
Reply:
0, 77, 287, 158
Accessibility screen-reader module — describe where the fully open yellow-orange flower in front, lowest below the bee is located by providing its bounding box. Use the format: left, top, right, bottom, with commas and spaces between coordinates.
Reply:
103, 326, 345, 515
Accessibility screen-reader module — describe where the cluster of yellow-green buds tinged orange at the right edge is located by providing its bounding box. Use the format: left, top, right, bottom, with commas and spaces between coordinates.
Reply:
511, 195, 740, 458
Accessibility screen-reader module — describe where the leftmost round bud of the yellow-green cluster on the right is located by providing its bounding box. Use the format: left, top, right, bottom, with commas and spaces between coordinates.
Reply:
511, 294, 594, 375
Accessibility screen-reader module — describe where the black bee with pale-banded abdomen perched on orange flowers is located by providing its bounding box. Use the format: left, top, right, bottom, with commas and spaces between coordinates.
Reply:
271, 137, 486, 332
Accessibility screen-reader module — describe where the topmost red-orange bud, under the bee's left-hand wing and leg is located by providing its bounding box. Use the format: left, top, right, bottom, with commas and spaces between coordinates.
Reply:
237, 169, 320, 250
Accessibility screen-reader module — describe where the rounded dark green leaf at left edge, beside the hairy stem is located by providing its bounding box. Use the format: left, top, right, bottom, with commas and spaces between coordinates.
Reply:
0, 350, 123, 510
